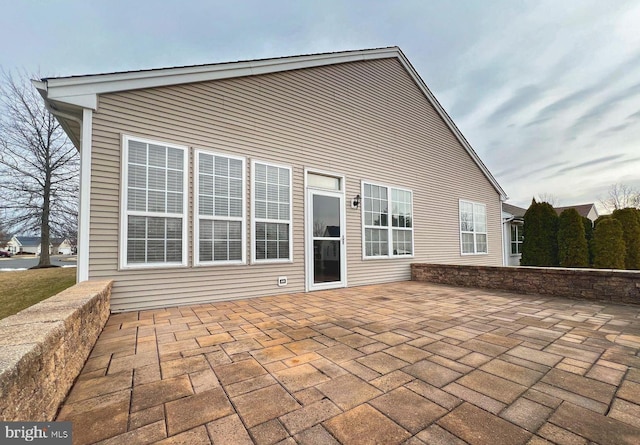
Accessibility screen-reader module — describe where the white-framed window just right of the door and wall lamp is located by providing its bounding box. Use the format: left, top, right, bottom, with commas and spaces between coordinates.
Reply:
362, 182, 413, 258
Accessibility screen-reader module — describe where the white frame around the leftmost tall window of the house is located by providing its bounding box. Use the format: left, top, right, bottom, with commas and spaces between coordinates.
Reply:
119, 134, 189, 270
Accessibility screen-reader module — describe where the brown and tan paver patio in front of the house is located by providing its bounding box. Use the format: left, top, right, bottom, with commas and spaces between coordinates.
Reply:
57, 282, 640, 445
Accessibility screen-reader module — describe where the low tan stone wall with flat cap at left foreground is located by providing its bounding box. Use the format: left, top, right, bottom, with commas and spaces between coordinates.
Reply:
0, 281, 112, 421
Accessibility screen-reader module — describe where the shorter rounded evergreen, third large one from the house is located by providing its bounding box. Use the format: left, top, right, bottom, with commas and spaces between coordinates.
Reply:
593, 217, 626, 269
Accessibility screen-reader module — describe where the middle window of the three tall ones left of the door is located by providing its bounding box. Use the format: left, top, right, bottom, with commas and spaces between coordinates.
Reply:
194, 150, 246, 265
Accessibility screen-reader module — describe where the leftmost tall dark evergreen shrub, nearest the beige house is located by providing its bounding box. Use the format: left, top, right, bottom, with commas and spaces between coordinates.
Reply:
520, 199, 558, 266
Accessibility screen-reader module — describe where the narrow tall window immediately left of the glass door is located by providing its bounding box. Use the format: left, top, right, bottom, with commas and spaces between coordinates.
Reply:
251, 161, 292, 262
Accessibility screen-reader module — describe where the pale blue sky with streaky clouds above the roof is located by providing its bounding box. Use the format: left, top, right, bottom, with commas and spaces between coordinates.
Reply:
0, 0, 640, 207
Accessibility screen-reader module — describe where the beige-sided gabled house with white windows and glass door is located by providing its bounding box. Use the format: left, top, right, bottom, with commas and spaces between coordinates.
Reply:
34, 47, 506, 311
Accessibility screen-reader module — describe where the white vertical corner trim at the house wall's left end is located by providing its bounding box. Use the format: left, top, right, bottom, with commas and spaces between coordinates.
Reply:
76, 108, 93, 283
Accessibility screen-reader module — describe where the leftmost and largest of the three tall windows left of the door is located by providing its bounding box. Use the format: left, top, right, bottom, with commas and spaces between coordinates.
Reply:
120, 136, 188, 268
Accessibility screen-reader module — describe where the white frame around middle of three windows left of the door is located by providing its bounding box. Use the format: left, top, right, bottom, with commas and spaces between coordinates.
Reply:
193, 149, 247, 267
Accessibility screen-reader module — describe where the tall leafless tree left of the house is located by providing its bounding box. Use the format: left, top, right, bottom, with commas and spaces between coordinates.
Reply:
0, 72, 79, 267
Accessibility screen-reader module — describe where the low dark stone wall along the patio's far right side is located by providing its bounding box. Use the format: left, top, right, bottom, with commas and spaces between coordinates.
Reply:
411, 264, 640, 304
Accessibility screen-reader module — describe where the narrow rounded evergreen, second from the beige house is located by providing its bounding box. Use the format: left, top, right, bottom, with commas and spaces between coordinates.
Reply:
558, 209, 589, 267
